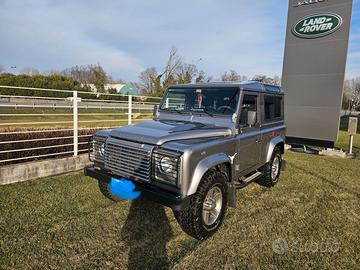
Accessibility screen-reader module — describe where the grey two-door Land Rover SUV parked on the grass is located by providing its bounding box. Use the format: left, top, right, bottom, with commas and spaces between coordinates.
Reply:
85, 81, 286, 239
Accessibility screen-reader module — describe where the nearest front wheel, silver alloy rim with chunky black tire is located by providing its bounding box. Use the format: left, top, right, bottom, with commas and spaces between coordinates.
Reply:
174, 170, 227, 240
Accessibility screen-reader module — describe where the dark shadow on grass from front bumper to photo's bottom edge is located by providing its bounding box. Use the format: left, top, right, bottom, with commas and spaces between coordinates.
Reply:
121, 198, 172, 269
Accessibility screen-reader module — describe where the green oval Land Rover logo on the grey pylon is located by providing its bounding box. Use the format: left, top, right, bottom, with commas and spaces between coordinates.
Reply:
292, 13, 342, 38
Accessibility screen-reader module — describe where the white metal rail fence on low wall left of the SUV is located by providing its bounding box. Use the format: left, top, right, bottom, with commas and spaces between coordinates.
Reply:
0, 86, 160, 166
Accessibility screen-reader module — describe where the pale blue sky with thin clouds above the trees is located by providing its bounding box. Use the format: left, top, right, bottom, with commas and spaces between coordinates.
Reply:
0, 0, 360, 81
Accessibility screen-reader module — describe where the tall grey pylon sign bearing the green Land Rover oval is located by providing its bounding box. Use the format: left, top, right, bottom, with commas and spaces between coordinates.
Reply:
282, 0, 353, 147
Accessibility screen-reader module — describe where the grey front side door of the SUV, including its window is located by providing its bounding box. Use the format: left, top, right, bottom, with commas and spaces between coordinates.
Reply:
238, 91, 261, 172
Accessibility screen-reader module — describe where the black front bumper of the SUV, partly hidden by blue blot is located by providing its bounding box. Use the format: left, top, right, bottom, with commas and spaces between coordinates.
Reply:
84, 165, 189, 211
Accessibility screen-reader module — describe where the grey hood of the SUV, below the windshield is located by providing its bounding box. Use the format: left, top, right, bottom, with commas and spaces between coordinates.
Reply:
110, 120, 232, 145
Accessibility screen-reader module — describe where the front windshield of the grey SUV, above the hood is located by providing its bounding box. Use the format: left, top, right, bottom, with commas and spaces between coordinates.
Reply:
160, 88, 239, 116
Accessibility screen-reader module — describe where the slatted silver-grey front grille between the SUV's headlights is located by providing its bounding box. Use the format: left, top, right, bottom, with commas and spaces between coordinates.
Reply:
105, 138, 153, 181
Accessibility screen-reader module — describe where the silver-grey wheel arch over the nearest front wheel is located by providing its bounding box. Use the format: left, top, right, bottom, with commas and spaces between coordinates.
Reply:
186, 153, 232, 195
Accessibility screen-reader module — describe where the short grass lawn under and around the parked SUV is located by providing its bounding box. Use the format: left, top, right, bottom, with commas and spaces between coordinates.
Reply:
0, 141, 360, 269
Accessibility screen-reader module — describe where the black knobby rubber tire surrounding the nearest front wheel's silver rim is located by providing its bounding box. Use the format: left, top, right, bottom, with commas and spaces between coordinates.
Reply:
174, 169, 227, 240
